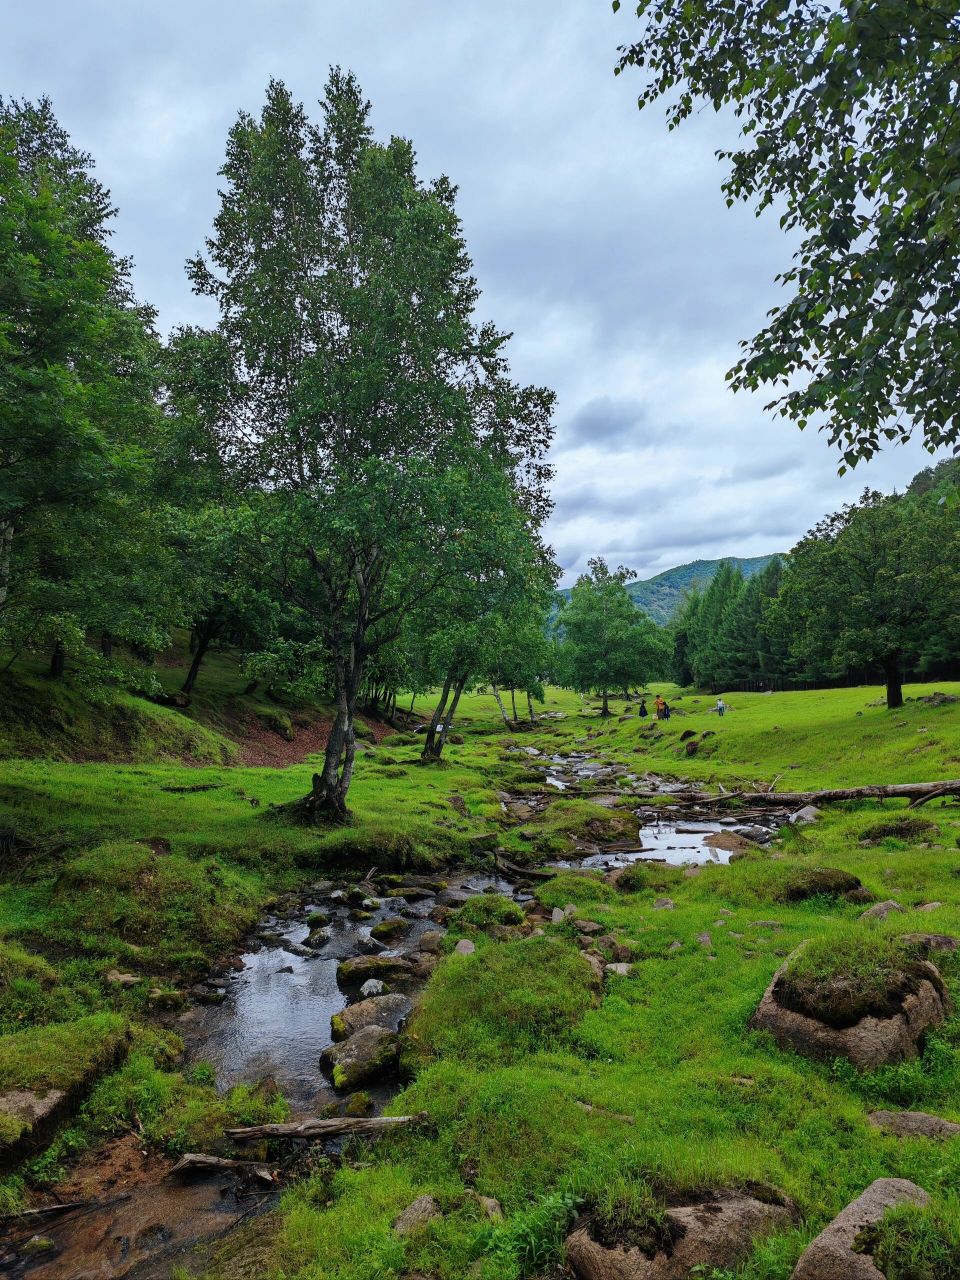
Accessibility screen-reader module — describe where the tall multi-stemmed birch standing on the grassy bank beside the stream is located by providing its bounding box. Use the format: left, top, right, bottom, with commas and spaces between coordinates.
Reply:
189, 77, 553, 820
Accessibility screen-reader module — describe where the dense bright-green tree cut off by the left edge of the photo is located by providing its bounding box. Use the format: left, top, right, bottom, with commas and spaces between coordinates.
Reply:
0, 100, 177, 675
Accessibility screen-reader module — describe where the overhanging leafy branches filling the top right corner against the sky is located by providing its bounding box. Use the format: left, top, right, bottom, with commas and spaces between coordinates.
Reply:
613, 0, 960, 472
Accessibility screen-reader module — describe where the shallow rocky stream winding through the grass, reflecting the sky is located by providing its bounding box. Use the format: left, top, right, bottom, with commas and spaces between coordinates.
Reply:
0, 748, 782, 1280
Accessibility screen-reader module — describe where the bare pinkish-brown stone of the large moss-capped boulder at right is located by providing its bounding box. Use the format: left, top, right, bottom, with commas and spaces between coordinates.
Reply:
750, 961, 948, 1070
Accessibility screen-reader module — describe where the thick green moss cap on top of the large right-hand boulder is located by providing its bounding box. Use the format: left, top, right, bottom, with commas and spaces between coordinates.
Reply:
774, 932, 942, 1028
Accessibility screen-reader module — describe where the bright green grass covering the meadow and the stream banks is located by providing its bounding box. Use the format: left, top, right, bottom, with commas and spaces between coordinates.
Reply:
0, 657, 960, 1280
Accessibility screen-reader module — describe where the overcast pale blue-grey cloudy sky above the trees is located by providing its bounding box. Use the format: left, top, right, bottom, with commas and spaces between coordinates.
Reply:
0, 0, 947, 582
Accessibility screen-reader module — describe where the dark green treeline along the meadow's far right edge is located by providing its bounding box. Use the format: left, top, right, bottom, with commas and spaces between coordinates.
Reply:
671, 460, 960, 707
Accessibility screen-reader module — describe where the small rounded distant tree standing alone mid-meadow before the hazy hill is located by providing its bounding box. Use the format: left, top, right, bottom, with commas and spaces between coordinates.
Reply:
557, 558, 667, 716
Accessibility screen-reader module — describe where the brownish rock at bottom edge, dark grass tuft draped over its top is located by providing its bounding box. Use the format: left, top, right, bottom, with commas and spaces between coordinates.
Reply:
567, 1189, 798, 1280
